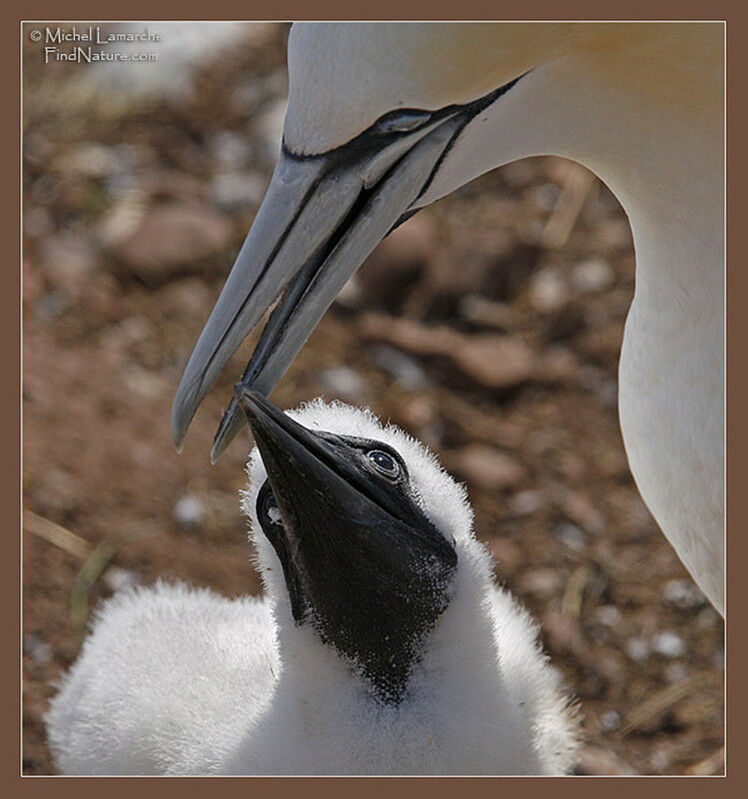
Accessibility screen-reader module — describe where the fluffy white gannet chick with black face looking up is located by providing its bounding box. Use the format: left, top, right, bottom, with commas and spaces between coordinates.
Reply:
47, 389, 577, 774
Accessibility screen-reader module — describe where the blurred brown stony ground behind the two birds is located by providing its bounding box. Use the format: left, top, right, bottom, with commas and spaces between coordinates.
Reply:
23, 23, 724, 774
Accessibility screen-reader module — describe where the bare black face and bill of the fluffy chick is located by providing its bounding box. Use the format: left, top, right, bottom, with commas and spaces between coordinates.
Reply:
240, 389, 457, 704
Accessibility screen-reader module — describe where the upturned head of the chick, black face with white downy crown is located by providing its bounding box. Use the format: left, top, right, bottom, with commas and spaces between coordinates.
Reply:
240, 389, 472, 704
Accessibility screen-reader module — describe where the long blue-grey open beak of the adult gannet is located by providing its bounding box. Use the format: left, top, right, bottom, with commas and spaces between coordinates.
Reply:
172, 107, 466, 461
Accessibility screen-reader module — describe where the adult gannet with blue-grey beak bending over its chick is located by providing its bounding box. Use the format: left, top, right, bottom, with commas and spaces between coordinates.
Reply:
172, 23, 724, 613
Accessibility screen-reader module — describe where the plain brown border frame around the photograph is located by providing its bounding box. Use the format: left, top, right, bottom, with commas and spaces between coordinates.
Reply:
5, 0, 748, 797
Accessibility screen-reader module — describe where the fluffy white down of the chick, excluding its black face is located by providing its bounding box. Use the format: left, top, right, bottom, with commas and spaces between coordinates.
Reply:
47, 401, 577, 774
